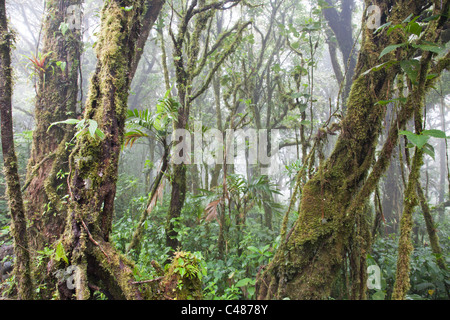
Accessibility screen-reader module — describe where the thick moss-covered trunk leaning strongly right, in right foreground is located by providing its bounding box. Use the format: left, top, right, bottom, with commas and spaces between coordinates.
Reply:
256, 1, 448, 299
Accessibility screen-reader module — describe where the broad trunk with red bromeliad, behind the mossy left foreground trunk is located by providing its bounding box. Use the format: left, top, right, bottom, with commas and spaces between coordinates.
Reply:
25, 0, 82, 250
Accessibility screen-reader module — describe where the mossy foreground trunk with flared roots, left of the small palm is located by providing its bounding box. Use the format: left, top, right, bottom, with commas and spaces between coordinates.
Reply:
54, 0, 161, 299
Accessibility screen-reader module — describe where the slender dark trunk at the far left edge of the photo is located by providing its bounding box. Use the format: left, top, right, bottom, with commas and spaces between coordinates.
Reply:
0, 0, 33, 299
